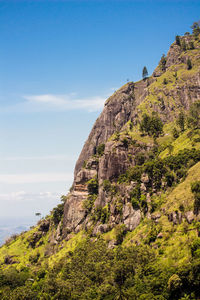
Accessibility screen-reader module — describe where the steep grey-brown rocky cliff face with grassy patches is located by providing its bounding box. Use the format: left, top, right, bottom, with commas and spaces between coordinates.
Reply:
63, 37, 200, 237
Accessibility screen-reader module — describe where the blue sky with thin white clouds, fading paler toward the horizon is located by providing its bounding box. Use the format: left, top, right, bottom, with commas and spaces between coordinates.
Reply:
0, 0, 200, 218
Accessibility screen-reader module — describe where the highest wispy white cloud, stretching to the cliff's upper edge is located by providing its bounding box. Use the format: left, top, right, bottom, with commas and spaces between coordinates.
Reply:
0, 94, 107, 113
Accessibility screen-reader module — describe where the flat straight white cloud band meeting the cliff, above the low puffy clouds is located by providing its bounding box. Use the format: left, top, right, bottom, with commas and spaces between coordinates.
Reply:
0, 173, 73, 184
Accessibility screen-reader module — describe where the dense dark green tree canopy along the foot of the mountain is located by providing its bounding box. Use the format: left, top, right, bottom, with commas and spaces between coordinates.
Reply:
0, 237, 200, 300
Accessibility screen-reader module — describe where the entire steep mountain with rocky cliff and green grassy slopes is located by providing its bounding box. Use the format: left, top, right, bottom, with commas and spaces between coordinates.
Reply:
0, 24, 200, 300
